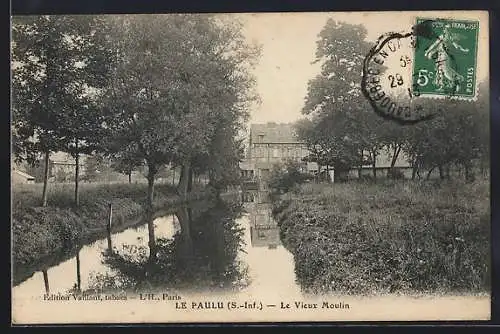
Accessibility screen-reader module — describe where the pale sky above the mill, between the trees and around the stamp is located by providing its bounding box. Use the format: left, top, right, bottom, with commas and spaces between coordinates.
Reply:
230, 11, 489, 123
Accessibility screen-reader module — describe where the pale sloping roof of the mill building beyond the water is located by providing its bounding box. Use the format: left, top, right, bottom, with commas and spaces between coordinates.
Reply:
250, 122, 300, 143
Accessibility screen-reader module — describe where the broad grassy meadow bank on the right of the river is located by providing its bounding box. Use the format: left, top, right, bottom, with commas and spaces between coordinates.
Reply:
273, 181, 491, 295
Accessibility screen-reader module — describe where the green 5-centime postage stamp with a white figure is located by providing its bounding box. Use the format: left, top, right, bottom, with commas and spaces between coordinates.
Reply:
413, 18, 479, 98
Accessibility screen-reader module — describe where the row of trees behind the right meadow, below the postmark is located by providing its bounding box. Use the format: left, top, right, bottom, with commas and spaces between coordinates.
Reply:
296, 20, 489, 180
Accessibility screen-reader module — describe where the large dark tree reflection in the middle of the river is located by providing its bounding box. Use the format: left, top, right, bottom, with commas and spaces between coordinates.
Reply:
90, 200, 250, 292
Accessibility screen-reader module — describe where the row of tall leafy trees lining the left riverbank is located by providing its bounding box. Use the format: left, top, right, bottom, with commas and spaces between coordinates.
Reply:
12, 14, 259, 208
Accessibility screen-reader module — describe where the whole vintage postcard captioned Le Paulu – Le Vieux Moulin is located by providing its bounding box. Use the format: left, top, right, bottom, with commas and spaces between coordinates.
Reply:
11, 11, 491, 324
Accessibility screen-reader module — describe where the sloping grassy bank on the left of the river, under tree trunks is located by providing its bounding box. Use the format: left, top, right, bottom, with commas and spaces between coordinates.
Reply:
12, 184, 215, 275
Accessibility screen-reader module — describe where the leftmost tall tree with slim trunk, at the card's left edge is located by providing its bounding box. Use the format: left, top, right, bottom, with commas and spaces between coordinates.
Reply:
12, 16, 68, 206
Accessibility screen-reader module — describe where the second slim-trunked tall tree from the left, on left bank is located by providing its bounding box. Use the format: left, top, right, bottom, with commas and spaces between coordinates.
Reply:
54, 15, 115, 207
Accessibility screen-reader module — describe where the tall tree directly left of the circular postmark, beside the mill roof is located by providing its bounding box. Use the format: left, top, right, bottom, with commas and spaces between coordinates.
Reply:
302, 19, 378, 179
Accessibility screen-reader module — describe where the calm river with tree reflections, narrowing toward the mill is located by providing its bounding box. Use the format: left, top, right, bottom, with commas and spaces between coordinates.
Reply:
13, 194, 301, 298
